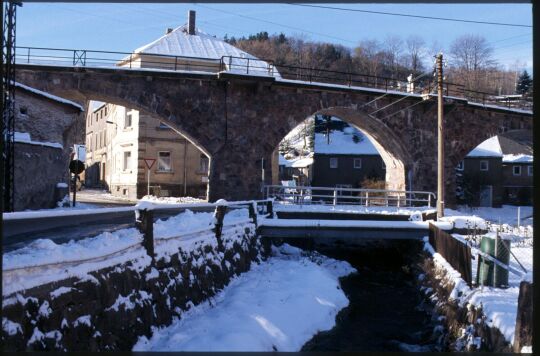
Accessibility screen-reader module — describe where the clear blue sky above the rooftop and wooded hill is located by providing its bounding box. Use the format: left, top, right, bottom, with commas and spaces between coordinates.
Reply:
17, 3, 532, 71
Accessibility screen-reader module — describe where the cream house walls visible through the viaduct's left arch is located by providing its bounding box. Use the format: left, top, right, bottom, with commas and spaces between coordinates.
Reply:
85, 104, 209, 199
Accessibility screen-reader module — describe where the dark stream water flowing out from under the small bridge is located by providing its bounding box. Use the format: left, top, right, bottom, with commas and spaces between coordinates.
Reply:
302, 242, 448, 352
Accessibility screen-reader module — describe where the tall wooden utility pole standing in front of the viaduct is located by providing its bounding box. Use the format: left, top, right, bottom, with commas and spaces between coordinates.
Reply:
436, 53, 444, 218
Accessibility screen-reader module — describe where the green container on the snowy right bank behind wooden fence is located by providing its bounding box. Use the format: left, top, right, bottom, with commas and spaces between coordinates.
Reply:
476, 236, 510, 288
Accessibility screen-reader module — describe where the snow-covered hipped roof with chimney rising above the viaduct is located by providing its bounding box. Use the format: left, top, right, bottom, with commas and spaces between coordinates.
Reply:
134, 24, 279, 77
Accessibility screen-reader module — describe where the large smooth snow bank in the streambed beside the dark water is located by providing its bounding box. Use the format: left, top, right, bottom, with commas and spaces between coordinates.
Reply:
133, 244, 356, 351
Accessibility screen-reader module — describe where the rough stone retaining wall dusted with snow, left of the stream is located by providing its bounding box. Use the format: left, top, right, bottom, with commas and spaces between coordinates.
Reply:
2, 224, 270, 351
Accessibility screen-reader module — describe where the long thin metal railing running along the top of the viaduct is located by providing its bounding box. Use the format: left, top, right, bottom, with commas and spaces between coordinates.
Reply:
15, 46, 532, 110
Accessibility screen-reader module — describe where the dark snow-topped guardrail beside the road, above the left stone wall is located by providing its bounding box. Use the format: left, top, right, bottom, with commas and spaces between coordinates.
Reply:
3, 200, 272, 251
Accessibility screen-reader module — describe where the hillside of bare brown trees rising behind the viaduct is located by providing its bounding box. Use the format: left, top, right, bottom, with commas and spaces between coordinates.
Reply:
225, 32, 532, 97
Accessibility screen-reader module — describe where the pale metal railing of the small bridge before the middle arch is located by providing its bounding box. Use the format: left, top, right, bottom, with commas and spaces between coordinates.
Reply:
263, 185, 436, 207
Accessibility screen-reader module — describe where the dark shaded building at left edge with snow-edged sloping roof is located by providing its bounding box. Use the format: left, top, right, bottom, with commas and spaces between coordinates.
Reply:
14, 83, 84, 211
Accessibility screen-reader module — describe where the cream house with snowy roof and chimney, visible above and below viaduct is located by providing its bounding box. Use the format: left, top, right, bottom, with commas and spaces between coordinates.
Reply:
85, 11, 279, 199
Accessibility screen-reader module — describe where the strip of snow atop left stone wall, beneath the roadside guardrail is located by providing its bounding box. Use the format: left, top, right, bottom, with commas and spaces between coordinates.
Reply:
2, 209, 250, 295
